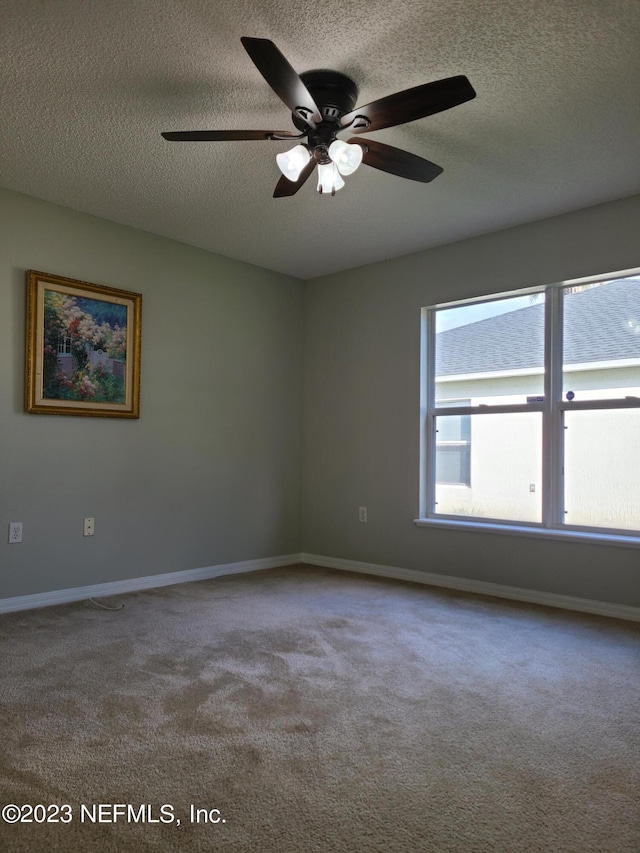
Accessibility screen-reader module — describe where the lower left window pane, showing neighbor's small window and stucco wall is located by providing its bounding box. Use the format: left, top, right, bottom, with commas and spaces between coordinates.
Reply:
435, 412, 542, 522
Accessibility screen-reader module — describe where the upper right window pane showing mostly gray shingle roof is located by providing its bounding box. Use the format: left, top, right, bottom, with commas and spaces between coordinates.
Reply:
562, 276, 640, 400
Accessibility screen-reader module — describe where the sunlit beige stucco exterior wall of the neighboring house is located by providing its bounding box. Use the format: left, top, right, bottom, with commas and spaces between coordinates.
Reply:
436, 364, 640, 530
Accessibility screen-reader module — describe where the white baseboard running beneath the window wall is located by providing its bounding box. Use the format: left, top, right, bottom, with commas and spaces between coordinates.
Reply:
301, 554, 640, 622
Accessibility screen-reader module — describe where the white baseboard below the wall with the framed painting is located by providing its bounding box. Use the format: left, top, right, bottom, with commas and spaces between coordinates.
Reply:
0, 554, 302, 613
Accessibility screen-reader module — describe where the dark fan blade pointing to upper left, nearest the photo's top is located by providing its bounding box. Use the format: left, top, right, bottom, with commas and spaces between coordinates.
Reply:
240, 36, 322, 127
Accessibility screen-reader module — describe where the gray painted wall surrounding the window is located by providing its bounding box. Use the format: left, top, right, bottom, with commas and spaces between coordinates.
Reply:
303, 196, 640, 607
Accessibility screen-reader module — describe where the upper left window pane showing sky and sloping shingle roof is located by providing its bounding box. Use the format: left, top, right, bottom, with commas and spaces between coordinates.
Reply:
435, 293, 544, 406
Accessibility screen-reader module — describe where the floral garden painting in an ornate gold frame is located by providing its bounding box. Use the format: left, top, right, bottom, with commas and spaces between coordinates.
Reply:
25, 270, 142, 418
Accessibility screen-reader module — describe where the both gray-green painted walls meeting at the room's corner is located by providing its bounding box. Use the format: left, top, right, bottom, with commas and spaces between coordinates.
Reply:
0, 190, 640, 606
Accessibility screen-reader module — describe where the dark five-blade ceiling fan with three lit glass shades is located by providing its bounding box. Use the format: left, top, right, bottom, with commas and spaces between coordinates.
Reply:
162, 37, 476, 198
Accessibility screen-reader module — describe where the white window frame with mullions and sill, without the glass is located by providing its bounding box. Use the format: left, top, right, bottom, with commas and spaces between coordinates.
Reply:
414, 269, 640, 547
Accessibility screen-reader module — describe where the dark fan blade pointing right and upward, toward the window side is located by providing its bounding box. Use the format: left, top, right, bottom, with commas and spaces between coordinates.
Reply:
340, 74, 476, 133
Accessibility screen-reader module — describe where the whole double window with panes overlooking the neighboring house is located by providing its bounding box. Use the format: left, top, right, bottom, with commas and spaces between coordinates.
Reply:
417, 273, 640, 538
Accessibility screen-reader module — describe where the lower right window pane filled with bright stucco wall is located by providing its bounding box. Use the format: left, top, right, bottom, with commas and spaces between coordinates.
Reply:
564, 409, 640, 530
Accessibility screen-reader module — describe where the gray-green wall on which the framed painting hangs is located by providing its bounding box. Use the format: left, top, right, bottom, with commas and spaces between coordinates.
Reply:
0, 190, 303, 599
